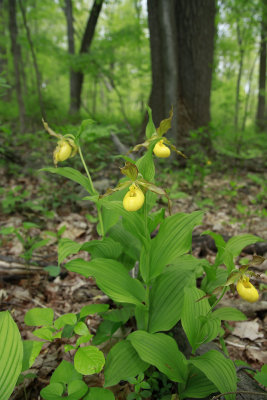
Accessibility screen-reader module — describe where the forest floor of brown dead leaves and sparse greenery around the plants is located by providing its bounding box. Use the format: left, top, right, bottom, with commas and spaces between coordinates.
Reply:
0, 148, 267, 400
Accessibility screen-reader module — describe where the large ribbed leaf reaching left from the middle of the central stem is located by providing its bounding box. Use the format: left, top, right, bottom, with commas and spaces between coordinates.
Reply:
66, 258, 145, 306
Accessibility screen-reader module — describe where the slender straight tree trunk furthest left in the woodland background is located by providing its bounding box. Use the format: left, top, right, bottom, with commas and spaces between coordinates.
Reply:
8, 0, 25, 132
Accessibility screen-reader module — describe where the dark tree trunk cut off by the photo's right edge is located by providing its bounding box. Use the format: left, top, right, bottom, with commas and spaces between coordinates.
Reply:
256, 0, 267, 132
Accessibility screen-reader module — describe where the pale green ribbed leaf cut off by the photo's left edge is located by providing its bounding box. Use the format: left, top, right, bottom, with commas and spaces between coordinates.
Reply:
0, 311, 23, 400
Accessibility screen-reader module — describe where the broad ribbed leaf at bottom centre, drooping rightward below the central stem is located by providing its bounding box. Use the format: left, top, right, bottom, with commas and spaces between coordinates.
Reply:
128, 331, 187, 382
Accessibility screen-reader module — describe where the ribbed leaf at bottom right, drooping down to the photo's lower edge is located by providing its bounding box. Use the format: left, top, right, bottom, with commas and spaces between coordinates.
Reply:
190, 350, 237, 400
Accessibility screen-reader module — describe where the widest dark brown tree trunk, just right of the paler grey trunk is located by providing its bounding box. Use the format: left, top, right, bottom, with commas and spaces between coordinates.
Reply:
175, 0, 216, 150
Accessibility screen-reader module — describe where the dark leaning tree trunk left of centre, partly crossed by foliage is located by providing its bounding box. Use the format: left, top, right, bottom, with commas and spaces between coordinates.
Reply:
68, 0, 104, 114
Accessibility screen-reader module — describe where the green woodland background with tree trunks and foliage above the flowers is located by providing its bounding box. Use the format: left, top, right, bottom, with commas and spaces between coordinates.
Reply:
0, 0, 267, 156
